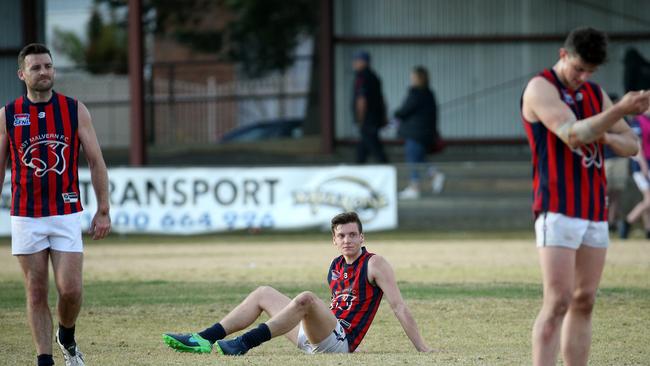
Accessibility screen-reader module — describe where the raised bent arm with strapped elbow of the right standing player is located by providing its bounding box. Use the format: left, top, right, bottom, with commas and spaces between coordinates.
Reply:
522, 77, 650, 148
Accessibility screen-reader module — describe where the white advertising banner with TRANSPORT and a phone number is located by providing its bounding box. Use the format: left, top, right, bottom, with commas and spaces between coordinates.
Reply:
0, 166, 397, 236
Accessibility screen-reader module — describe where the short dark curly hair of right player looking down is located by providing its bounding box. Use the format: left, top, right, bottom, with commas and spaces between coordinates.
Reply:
564, 27, 607, 66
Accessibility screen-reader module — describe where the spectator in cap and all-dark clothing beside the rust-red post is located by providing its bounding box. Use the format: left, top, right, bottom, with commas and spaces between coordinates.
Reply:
352, 51, 388, 164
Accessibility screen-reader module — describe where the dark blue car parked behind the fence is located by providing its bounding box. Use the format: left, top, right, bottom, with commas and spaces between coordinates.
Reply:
219, 119, 303, 143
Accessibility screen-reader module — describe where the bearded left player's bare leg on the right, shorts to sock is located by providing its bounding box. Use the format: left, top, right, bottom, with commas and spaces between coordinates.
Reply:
51, 250, 83, 328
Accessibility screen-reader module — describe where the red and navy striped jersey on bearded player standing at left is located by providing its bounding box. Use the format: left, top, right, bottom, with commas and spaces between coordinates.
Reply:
5, 92, 82, 217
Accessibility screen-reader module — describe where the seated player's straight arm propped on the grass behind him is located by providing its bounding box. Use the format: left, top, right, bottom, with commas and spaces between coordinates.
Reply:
368, 255, 431, 352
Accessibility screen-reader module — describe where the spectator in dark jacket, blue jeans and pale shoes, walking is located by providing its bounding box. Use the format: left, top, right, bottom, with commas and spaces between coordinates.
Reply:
395, 66, 445, 199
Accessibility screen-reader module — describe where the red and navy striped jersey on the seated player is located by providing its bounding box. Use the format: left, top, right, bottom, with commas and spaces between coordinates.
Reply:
327, 247, 384, 352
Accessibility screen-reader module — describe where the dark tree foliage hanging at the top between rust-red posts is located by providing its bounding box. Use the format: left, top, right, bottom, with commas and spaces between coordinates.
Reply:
96, 0, 318, 76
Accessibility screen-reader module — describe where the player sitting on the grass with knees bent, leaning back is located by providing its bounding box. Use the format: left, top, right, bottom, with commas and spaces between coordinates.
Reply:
163, 212, 431, 355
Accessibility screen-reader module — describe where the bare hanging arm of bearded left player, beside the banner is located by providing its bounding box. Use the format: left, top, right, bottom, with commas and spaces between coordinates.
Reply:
78, 102, 111, 240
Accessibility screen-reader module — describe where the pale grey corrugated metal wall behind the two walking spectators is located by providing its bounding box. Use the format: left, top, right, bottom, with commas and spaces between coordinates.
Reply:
334, 0, 650, 139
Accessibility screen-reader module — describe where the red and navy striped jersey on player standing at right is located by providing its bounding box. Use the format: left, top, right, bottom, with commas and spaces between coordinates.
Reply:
521, 70, 607, 221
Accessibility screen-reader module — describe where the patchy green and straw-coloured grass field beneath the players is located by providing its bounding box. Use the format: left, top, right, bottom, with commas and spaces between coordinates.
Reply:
0, 233, 650, 366
